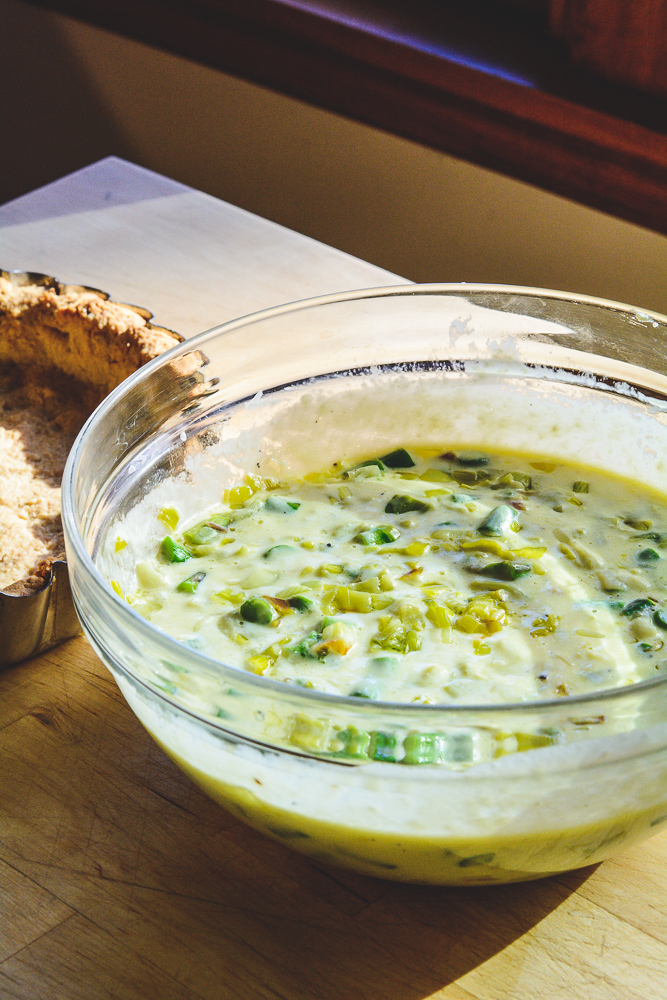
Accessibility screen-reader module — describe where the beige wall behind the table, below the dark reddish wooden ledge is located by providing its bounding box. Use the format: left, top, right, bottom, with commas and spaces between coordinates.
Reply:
0, 0, 667, 312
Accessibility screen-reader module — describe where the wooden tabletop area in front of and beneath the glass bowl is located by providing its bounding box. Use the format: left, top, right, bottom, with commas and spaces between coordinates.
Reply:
0, 638, 667, 1000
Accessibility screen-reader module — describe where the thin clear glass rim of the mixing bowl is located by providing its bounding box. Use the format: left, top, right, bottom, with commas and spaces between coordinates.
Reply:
62, 282, 667, 732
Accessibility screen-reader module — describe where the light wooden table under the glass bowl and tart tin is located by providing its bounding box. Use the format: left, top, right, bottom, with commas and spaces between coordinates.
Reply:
0, 159, 667, 1000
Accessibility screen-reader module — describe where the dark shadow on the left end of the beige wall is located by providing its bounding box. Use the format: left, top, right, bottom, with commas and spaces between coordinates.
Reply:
0, 0, 136, 204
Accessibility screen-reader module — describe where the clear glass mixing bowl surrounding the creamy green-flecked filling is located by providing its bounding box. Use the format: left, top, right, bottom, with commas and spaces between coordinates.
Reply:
63, 284, 667, 884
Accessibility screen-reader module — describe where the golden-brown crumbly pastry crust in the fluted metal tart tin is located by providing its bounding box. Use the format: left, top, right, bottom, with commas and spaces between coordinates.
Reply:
0, 276, 180, 595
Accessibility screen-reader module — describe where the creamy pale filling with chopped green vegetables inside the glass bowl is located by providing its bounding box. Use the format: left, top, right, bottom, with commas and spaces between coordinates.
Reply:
115, 448, 667, 704
